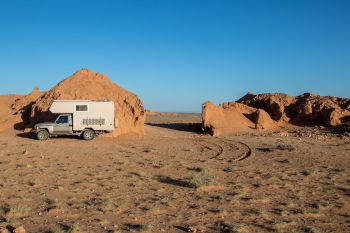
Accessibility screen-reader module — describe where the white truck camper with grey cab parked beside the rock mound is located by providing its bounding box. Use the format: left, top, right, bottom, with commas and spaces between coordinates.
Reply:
34, 100, 117, 140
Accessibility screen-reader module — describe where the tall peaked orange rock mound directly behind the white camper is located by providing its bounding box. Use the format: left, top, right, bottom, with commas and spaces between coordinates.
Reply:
29, 69, 145, 136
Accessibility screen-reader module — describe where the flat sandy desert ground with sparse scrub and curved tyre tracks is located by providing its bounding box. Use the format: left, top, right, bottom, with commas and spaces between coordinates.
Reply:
0, 114, 350, 233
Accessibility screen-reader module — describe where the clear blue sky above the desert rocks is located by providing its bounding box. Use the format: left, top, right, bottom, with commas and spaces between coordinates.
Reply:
0, 0, 350, 112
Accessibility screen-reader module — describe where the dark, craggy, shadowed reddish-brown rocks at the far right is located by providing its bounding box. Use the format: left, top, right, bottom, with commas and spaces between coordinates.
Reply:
238, 93, 350, 126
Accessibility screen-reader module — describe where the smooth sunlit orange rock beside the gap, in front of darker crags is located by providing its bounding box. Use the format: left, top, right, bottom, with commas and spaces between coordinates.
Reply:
202, 102, 276, 136
